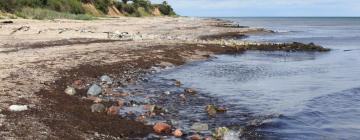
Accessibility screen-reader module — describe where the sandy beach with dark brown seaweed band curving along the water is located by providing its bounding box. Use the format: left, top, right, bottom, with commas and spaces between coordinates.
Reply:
0, 18, 326, 139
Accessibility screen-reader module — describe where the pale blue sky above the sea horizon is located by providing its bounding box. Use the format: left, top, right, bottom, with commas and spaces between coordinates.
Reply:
151, 0, 360, 17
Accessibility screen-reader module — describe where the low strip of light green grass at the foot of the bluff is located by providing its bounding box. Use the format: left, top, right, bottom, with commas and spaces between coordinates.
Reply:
15, 7, 96, 20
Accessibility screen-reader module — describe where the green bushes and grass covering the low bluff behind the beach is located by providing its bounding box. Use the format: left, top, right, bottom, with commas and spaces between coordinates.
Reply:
0, 0, 176, 20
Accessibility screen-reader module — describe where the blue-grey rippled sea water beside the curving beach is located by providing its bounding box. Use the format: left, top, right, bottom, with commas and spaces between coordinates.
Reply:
157, 18, 360, 140
